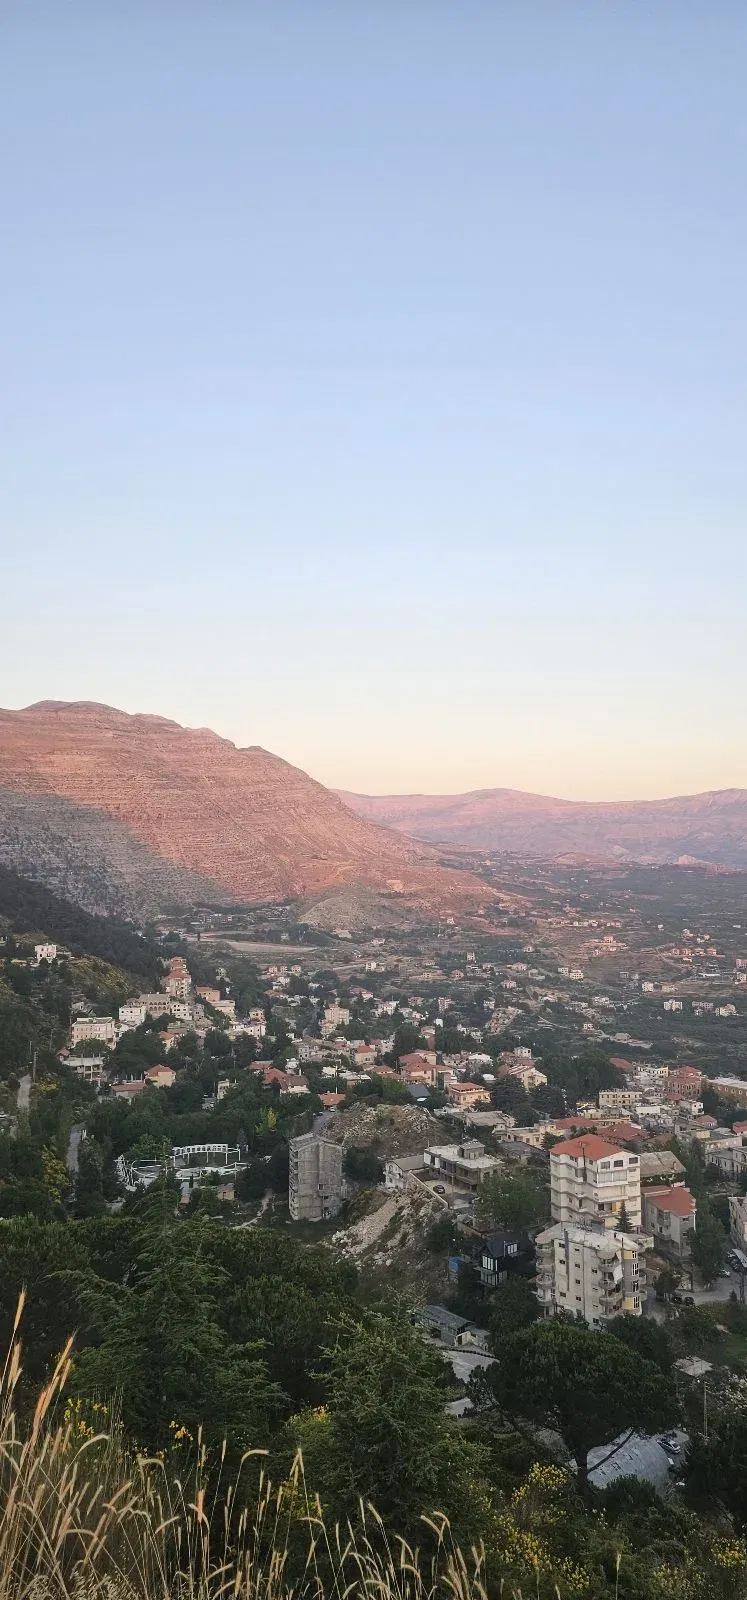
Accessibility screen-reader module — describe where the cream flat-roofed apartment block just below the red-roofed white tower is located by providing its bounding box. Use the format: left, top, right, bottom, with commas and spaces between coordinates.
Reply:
534, 1222, 646, 1328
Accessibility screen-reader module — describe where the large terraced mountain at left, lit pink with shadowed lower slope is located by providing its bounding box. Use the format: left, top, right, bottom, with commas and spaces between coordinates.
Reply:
0, 701, 489, 917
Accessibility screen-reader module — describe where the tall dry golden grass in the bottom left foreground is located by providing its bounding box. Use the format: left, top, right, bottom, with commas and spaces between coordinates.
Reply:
0, 1301, 485, 1600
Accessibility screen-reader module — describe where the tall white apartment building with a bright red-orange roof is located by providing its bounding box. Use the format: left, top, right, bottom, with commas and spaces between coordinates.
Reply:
550, 1133, 641, 1229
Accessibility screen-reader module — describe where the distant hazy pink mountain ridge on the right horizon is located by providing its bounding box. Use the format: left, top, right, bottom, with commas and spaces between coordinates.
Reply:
338, 789, 747, 870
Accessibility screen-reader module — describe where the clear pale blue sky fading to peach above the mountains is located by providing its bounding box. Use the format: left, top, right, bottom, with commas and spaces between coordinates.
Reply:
0, 0, 747, 798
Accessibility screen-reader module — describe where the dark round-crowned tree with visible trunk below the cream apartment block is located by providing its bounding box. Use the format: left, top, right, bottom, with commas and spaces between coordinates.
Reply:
488, 1320, 677, 1490
